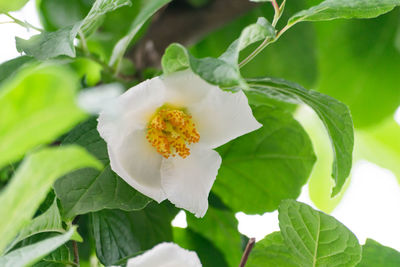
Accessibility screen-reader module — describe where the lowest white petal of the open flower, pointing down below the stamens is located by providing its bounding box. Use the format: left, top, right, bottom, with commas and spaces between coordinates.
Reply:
161, 146, 221, 217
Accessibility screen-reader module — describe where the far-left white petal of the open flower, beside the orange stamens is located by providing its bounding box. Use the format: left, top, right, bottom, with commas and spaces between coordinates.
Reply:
97, 77, 166, 144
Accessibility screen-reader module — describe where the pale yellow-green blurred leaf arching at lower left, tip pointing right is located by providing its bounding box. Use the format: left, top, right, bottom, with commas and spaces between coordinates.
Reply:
0, 146, 101, 254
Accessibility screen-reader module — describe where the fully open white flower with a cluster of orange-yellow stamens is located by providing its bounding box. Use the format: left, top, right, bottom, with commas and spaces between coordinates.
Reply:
97, 71, 262, 217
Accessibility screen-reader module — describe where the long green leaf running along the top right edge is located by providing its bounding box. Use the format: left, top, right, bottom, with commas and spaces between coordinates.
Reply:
289, 0, 400, 24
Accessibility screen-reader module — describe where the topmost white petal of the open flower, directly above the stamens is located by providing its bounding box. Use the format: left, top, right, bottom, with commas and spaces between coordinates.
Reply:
162, 70, 214, 107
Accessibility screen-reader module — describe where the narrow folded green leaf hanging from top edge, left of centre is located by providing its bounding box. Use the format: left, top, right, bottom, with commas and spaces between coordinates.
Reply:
109, 0, 171, 67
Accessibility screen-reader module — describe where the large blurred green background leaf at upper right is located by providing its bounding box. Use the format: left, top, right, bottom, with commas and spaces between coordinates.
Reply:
316, 10, 400, 128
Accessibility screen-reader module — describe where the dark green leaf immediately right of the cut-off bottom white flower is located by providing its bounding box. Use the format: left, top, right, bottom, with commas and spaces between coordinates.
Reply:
173, 227, 228, 267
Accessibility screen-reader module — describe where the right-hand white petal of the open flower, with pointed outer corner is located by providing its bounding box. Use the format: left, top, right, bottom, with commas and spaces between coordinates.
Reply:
188, 88, 262, 148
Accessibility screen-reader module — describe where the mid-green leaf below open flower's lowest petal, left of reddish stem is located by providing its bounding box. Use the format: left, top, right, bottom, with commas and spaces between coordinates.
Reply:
187, 207, 242, 266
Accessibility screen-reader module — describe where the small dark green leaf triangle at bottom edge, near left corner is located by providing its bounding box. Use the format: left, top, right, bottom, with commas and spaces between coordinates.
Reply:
32, 245, 75, 267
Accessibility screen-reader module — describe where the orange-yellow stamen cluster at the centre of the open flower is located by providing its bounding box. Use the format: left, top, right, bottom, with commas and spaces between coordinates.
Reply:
146, 108, 200, 158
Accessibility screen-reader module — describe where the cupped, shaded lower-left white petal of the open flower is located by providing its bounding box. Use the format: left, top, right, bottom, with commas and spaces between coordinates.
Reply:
107, 130, 166, 202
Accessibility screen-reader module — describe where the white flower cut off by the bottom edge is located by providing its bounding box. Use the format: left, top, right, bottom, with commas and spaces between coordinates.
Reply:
127, 243, 201, 267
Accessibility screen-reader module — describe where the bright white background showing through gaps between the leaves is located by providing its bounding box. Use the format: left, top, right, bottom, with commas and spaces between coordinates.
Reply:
0, 0, 400, 253
